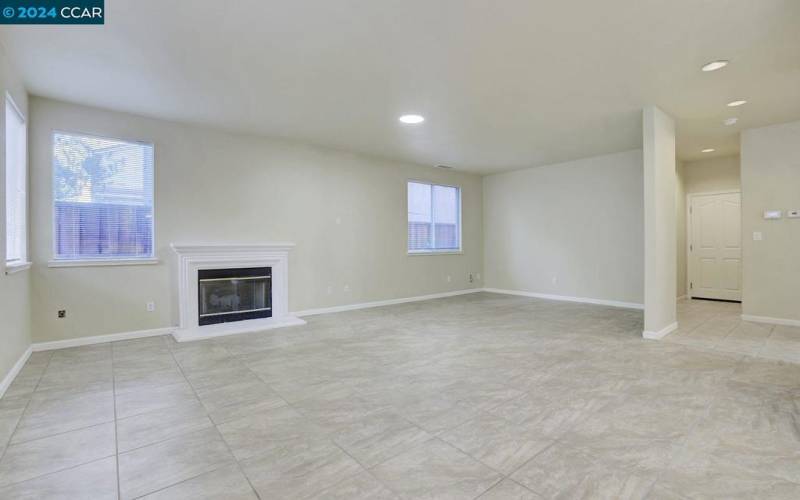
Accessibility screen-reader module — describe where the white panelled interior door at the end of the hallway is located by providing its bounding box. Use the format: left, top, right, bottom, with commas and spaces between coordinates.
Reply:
689, 193, 742, 301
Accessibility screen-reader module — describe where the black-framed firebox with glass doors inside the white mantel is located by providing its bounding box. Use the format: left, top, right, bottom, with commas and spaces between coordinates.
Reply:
197, 267, 272, 326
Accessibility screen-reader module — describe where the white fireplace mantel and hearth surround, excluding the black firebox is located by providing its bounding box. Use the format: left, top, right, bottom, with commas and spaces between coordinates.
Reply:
171, 242, 305, 342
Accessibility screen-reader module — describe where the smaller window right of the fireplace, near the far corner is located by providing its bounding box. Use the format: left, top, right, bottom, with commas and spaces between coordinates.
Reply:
408, 181, 461, 253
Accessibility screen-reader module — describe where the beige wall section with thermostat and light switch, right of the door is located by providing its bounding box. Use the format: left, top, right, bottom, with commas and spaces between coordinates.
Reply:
741, 122, 800, 324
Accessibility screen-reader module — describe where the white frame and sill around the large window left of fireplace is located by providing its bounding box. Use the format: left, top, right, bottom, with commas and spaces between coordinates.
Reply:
47, 129, 160, 267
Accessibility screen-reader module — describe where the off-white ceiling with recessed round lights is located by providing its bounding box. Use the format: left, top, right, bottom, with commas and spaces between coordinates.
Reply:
0, 0, 800, 173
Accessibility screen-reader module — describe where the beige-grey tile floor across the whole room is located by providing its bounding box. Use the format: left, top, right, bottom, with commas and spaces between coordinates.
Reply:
0, 293, 800, 500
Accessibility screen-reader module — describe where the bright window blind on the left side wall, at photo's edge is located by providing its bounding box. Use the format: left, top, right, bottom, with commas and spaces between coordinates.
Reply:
6, 95, 28, 264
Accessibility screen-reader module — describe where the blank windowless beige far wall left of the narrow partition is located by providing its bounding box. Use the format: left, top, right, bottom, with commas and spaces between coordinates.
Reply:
483, 150, 644, 304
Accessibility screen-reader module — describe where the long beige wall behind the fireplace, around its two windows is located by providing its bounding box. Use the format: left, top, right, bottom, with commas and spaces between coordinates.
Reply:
30, 98, 483, 341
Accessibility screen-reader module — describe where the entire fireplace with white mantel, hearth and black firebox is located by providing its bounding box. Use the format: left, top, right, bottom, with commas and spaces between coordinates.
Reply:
171, 243, 305, 342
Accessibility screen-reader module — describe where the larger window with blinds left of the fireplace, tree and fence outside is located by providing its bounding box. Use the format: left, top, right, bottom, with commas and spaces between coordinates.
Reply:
53, 132, 153, 260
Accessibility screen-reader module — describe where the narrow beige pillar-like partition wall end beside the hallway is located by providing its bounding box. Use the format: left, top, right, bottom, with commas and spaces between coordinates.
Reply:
642, 106, 678, 337
